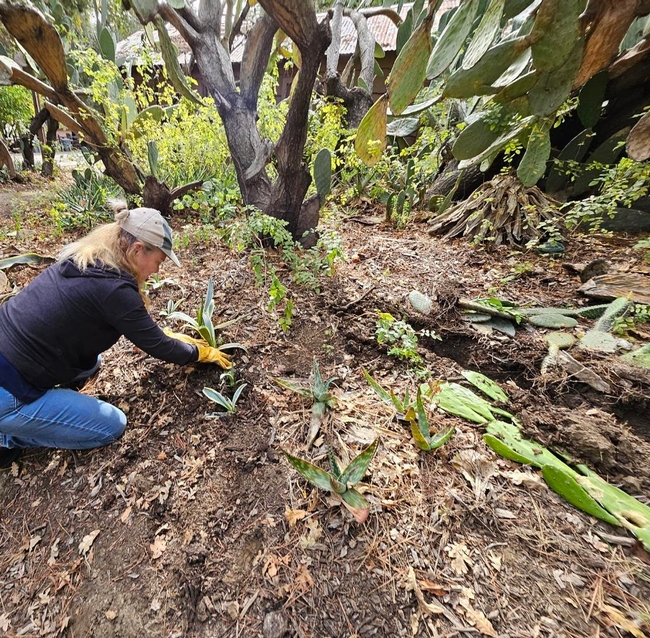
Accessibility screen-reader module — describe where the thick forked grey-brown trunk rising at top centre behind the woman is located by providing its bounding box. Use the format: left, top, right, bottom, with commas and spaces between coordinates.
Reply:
186, 0, 329, 241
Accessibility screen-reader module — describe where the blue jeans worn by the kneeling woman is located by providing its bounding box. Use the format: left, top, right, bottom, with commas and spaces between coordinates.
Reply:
0, 362, 126, 450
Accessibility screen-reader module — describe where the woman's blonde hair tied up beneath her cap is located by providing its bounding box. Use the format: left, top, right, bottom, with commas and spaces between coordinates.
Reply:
59, 200, 155, 288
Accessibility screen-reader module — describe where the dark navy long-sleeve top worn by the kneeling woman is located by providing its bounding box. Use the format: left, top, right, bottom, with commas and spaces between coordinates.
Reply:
0, 260, 198, 391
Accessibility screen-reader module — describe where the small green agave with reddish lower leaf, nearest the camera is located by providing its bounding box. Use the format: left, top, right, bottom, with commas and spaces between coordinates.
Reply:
284, 439, 379, 523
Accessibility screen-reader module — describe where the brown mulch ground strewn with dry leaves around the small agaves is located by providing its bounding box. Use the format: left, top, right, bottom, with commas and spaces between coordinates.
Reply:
0, 189, 650, 638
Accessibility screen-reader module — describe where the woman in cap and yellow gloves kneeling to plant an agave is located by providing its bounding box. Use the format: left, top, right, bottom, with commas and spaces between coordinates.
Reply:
0, 205, 230, 467
